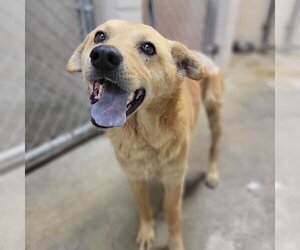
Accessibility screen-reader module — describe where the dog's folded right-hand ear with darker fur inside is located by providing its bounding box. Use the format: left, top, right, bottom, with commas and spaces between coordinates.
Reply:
170, 41, 204, 80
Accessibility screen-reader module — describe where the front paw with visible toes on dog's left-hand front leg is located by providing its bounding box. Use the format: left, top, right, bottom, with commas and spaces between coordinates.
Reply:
136, 223, 154, 250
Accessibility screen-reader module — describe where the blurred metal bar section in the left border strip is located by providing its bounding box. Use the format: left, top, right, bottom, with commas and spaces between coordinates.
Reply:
0, 143, 25, 175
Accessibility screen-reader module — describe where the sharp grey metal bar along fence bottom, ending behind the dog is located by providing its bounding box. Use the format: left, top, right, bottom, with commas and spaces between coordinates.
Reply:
25, 123, 101, 173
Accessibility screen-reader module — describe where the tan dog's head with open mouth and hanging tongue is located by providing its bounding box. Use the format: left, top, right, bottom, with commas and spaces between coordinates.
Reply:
67, 20, 203, 128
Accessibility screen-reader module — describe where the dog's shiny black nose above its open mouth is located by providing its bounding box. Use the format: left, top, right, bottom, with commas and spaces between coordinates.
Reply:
90, 45, 123, 70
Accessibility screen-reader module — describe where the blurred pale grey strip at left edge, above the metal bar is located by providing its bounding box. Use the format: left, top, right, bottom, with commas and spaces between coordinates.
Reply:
0, 0, 25, 151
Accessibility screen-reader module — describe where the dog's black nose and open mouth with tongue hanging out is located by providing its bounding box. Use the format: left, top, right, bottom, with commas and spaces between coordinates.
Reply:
90, 45, 146, 128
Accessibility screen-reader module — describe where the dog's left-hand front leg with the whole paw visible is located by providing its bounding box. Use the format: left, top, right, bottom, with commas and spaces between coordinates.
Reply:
129, 180, 154, 250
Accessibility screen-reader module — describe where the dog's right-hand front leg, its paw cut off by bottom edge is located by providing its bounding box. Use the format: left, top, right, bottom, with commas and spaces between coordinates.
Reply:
164, 176, 184, 250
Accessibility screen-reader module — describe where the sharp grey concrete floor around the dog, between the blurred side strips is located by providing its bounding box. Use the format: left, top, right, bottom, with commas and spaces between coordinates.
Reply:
26, 55, 276, 250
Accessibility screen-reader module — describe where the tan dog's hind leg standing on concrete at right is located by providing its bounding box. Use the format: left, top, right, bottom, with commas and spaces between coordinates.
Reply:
203, 73, 223, 188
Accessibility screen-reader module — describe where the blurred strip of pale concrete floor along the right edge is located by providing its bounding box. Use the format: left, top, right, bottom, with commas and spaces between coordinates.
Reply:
276, 52, 300, 250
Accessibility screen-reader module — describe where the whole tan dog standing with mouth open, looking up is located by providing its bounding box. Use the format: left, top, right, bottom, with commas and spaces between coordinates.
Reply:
67, 20, 223, 250
